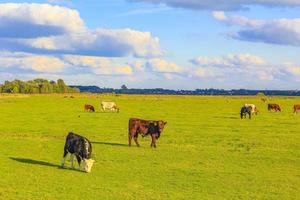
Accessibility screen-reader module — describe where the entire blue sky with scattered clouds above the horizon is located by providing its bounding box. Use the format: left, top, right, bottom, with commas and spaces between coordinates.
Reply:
0, 0, 300, 90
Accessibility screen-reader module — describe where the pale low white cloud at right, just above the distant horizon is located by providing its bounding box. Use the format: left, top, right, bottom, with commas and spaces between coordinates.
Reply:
190, 54, 300, 84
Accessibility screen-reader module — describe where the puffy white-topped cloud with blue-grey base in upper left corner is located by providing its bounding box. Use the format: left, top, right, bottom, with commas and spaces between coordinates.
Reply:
0, 3, 85, 38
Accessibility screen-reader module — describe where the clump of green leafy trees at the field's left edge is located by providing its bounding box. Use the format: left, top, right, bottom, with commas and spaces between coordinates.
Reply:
0, 79, 80, 94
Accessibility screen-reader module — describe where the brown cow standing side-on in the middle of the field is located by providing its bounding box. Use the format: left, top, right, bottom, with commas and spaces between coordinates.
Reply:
128, 118, 167, 148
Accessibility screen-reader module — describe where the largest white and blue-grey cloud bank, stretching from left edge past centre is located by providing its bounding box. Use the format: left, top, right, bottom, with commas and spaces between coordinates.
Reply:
0, 3, 162, 58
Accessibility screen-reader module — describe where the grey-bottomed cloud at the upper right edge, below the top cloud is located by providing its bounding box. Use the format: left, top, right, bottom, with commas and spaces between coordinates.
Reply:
213, 12, 300, 46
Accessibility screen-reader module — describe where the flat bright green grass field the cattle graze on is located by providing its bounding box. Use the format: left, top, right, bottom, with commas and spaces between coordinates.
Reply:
0, 95, 300, 200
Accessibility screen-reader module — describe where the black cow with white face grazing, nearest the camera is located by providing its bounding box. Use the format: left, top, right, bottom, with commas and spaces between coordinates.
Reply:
61, 132, 95, 172
